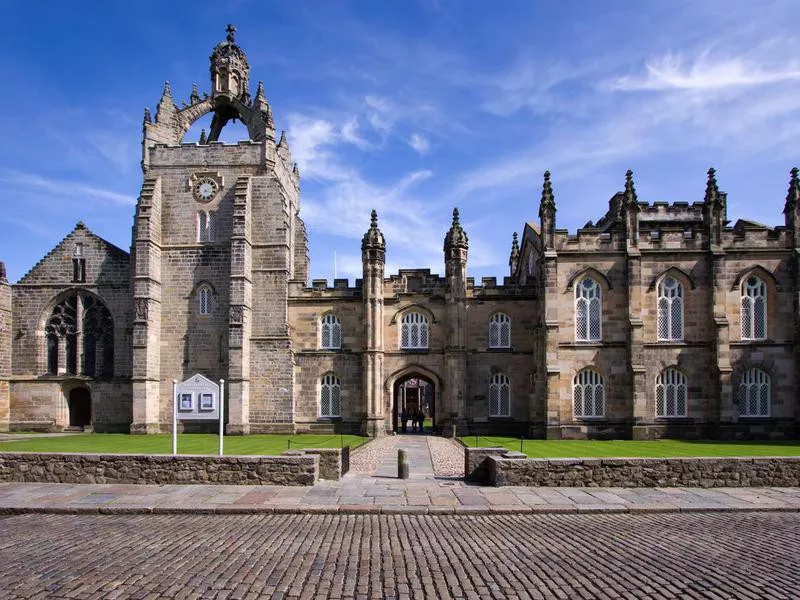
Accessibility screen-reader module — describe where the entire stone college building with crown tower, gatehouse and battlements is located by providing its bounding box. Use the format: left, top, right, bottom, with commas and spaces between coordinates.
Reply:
0, 27, 800, 438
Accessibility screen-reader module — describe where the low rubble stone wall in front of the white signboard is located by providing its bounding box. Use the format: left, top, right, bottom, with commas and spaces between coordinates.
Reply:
0, 452, 320, 485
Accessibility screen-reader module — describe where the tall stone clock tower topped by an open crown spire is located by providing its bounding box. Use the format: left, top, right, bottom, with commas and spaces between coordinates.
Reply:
131, 25, 308, 434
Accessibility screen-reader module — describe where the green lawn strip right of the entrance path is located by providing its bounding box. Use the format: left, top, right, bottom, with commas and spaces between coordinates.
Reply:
460, 435, 800, 458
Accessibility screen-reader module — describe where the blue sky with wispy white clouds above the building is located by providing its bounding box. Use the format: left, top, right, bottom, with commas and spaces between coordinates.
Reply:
0, 0, 800, 281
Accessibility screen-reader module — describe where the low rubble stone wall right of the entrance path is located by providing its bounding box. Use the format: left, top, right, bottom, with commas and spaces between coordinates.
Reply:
485, 453, 800, 488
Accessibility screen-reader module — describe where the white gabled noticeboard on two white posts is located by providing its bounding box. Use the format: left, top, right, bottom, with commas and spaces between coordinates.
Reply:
172, 373, 225, 456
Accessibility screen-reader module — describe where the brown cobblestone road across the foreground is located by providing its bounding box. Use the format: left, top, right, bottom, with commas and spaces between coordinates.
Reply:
0, 513, 800, 600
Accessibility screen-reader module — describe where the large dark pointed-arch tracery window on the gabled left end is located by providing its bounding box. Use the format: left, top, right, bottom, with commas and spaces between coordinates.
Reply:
44, 292, 114, 377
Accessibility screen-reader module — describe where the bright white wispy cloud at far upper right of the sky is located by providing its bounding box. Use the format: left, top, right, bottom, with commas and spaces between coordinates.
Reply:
606, 52, 800, 91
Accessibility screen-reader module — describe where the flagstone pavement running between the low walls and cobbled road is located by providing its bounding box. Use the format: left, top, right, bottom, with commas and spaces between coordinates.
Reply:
0, 476, 800, 514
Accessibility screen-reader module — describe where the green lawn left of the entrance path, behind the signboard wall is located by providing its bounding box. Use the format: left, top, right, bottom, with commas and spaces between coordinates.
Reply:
0, 433, 368, 455
